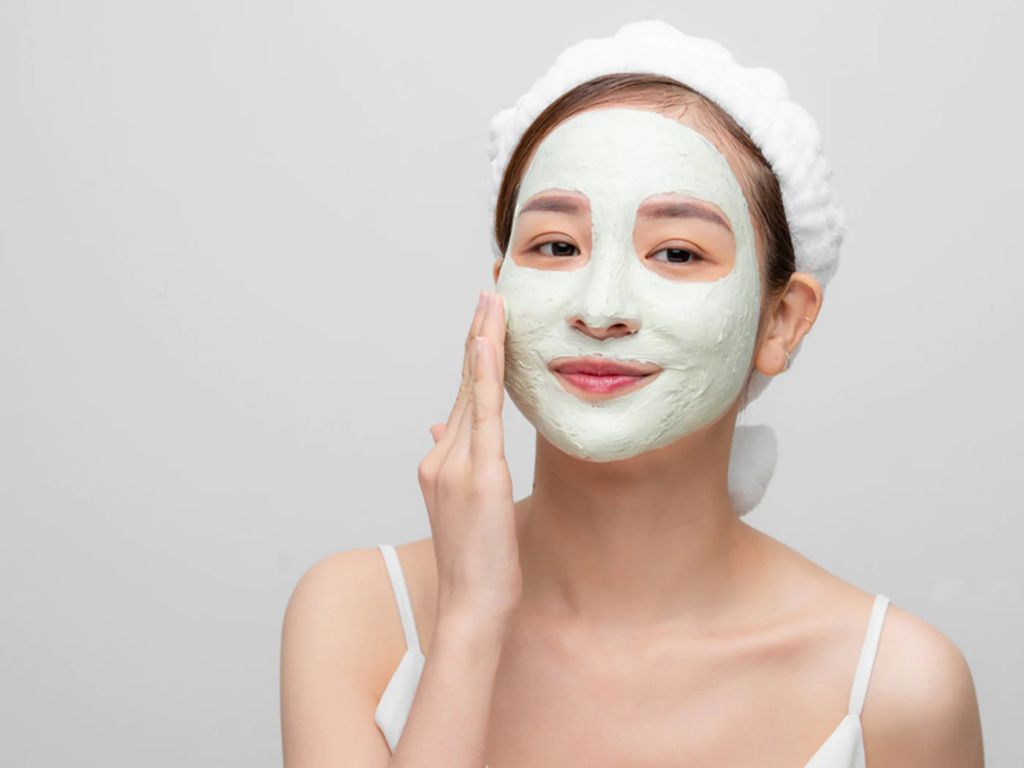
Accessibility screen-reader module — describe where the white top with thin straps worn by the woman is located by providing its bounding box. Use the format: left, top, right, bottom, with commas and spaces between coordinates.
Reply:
374, 544, 891, 768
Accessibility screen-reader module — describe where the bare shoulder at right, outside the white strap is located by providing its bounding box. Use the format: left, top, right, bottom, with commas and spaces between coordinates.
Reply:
861, 602, 983, 768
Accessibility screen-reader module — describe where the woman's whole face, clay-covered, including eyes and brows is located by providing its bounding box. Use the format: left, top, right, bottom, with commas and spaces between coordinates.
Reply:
496, 108, 761, 461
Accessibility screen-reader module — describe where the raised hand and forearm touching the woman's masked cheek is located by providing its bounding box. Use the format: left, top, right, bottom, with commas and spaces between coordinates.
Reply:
389, 294, 522, 768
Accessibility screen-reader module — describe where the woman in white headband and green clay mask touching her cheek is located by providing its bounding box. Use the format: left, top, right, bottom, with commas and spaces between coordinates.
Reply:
282, 22, 982, 768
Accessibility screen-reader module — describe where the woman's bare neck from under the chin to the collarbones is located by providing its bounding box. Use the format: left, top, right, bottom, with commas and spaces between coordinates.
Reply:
519, 405, 761, 627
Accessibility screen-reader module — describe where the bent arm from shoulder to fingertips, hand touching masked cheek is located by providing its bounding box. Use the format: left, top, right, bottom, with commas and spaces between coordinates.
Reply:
281, 292, 522, 768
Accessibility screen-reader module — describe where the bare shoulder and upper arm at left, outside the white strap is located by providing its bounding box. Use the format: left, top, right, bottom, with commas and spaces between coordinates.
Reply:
281, 545, 434, 765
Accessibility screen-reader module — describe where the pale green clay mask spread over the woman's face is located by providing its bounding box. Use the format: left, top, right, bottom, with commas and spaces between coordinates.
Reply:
497, 108, 761, 461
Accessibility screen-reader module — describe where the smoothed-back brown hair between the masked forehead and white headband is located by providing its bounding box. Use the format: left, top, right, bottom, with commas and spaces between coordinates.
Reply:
494, 73, 797, 336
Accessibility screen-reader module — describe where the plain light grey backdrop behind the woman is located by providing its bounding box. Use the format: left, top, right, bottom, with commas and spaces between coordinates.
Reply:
0, 0, 1024, 767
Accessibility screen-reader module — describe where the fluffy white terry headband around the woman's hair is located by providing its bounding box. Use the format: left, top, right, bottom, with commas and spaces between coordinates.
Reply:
488, 19, 846, 515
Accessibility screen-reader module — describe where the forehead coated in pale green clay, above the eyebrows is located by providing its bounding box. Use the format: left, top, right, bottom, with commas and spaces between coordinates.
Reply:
516, 108, 745, 222
